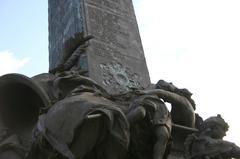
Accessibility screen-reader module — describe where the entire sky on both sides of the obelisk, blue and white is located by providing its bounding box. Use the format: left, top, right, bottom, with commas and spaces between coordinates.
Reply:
0, 0, 240, 145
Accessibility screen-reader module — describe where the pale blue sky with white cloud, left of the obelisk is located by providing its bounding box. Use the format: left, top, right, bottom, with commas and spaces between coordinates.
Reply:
0, 0, 48, 76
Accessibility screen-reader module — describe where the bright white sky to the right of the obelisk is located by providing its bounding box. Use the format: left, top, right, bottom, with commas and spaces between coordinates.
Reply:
134, 0, 240, 145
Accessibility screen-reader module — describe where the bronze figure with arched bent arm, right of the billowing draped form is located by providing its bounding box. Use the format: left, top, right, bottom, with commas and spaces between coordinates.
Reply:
118, 80, 197, 159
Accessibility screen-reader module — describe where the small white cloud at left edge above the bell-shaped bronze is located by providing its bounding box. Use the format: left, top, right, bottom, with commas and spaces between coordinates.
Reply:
0, 51, 30, 75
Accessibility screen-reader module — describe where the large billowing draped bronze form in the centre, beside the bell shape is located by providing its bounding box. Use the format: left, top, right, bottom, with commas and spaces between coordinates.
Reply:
29, 71, 129, 159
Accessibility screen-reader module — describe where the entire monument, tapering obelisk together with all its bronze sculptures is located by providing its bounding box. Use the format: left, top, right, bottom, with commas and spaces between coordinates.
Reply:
0, 0, 240, 159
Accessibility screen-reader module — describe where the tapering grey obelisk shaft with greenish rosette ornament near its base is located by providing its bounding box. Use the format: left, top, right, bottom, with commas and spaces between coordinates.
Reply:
48, 0, 150, 93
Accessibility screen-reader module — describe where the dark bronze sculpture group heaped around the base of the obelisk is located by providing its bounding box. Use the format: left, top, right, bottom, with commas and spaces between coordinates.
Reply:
0, 38, 240, 159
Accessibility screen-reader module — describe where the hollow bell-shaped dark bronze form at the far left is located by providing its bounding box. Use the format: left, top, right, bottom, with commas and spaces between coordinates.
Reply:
0, 74, 48, 159
